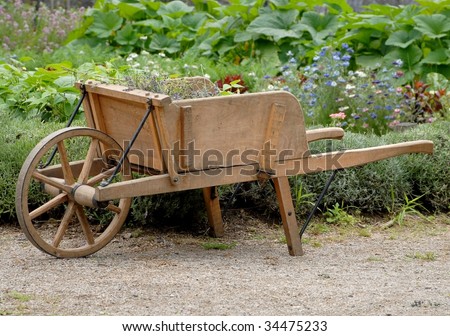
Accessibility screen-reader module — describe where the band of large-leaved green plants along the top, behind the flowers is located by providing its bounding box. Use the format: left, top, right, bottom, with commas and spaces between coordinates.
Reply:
69, 0, 450, 81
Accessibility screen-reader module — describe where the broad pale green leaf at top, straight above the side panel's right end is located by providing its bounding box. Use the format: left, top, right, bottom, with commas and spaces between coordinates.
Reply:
247, 10, 300, 42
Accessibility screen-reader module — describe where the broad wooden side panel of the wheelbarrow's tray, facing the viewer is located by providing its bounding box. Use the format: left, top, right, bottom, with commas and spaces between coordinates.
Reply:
166, 92, 308, 170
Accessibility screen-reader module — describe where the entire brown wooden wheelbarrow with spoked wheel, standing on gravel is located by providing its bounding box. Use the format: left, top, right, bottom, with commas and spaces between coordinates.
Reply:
16, 78, 433, 257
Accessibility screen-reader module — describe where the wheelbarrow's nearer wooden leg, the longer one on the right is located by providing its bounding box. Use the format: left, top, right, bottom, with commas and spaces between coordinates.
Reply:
273, 176, 303, 256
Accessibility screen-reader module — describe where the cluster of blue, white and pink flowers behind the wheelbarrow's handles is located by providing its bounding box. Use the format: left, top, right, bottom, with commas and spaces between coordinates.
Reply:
267, 44, 414, 134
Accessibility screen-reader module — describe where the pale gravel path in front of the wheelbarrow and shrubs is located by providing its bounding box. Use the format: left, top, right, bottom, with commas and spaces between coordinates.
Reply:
0, 215, 450, 316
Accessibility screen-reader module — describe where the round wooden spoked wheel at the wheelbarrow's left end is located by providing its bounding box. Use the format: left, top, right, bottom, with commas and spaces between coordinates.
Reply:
16, 127, 131, 258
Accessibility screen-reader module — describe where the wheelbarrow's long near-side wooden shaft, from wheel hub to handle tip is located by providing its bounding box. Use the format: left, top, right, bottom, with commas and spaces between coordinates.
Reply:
95, 140, 433, 201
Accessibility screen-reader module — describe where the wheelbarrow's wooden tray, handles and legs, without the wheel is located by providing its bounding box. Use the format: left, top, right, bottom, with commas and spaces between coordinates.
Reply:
72, 78, 433, 255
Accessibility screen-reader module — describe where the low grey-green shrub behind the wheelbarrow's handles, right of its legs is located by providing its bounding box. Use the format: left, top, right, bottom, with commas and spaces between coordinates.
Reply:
292, 122, 450, 213
